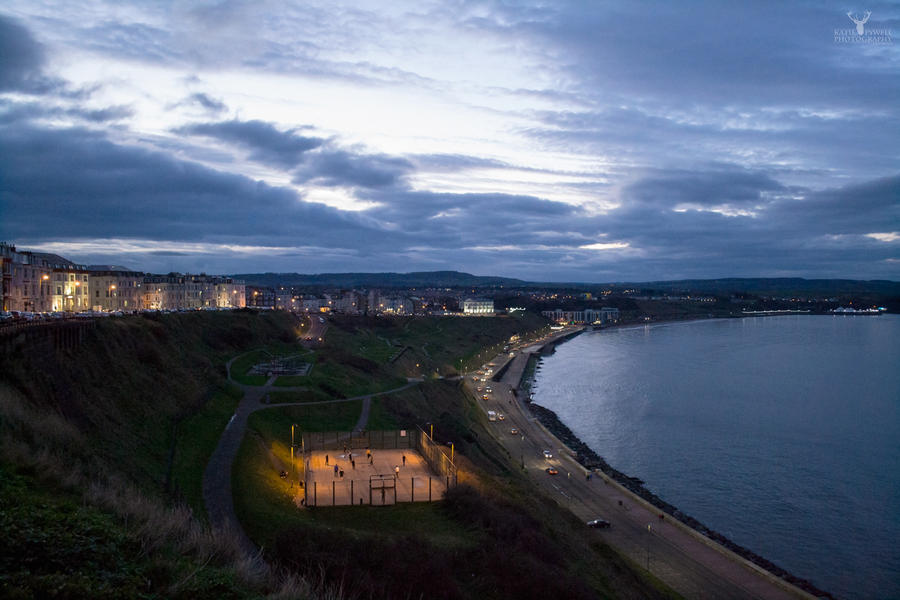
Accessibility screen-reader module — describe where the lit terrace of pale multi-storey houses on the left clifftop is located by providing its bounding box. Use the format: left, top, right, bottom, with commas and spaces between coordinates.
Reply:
0, 243, 246, 312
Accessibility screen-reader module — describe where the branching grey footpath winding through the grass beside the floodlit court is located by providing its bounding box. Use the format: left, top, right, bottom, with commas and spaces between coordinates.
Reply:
203, 355, 421, 556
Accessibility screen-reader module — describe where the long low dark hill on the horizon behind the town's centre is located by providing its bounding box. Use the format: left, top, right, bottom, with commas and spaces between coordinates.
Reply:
233, 271, 528, 288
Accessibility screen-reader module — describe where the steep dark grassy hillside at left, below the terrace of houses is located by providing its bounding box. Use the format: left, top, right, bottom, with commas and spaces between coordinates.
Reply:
0, 312, 316, 598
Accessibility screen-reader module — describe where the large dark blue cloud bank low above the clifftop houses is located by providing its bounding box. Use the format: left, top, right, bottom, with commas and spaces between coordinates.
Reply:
0, 124, 364, 245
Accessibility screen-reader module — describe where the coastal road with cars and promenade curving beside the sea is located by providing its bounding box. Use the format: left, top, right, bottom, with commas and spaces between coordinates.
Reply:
466, 336, 813, 600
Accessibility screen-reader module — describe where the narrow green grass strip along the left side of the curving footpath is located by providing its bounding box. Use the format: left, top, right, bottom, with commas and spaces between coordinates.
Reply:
172, 385, 243, 518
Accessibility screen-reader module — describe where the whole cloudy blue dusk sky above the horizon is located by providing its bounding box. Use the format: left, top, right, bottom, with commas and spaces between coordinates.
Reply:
0, 0, 900, 282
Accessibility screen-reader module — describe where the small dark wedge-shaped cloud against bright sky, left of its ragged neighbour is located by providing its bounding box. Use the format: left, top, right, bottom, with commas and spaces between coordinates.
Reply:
176, 120, 325, 168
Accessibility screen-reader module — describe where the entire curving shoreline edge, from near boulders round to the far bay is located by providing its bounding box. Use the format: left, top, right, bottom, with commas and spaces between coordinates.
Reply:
519, 317, 835, 600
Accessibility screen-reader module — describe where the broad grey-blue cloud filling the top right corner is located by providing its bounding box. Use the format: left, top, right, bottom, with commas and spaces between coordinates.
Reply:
482, 1, 900, 110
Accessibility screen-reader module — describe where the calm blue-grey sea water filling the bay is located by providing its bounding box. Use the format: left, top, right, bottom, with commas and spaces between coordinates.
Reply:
535, 315, 900, 599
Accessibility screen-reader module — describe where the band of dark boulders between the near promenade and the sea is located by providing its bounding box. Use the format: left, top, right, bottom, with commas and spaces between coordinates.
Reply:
529, 402, 834, 599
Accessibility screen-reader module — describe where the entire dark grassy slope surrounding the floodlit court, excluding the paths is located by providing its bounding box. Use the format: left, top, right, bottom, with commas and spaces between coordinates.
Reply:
0, 311, 666, 598
